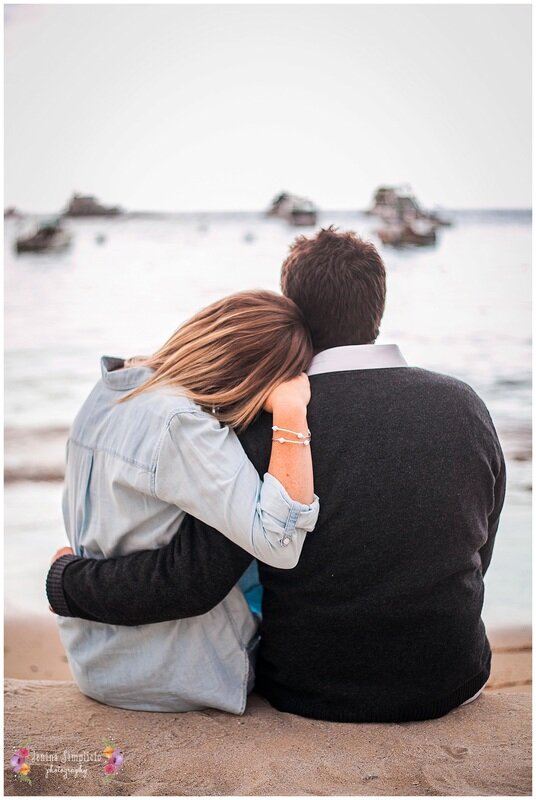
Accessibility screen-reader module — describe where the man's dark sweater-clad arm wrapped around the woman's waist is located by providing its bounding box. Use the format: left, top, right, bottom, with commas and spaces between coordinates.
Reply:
47, 516, 253, 625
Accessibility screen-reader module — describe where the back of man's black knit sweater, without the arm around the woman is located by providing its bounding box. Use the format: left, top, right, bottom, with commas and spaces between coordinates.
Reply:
242, 367, 505, 721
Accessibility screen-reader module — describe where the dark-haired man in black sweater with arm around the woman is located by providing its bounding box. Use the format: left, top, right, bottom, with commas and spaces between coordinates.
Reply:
47, 228, 505, 722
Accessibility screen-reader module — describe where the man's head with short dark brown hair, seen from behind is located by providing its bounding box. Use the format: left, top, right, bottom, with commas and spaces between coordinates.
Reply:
281, 226, 385, 351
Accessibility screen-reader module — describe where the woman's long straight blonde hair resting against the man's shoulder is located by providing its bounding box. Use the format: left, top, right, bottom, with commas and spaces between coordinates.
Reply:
120, 290, 313, 430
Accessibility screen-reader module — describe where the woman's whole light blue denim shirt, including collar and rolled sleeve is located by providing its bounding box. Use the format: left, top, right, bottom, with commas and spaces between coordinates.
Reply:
58, 357, 319, 714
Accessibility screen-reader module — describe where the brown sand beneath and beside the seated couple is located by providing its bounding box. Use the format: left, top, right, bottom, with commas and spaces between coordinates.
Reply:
5, 679, 531, 796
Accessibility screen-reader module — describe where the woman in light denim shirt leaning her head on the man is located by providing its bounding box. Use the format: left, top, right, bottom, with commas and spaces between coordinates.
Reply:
50, 291, 319, 713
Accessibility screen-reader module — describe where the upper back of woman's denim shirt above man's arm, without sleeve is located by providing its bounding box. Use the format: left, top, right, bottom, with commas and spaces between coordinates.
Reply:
63, 357, 197, 558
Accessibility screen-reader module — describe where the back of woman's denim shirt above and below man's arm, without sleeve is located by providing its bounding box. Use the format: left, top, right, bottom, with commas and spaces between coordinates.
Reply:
58, 358, 256, 713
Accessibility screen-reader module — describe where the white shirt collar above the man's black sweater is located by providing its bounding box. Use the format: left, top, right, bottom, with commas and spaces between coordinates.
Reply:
307, 344, 408, 375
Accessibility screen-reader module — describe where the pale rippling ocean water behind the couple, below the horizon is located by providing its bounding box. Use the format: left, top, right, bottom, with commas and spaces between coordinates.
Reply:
4, 211, 532, 626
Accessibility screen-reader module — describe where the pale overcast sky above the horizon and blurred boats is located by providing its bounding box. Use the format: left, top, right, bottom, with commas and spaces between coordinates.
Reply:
4, 5, 531, 211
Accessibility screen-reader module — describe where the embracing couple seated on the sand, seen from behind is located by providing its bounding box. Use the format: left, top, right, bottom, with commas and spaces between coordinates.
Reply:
47, 228, 505, 722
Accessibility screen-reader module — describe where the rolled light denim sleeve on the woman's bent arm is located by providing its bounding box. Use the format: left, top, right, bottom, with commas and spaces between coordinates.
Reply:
154, 409, 319, 569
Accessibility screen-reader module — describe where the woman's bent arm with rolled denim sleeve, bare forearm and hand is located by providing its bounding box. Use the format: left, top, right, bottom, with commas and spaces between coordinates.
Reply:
153, 376, 319, 569
